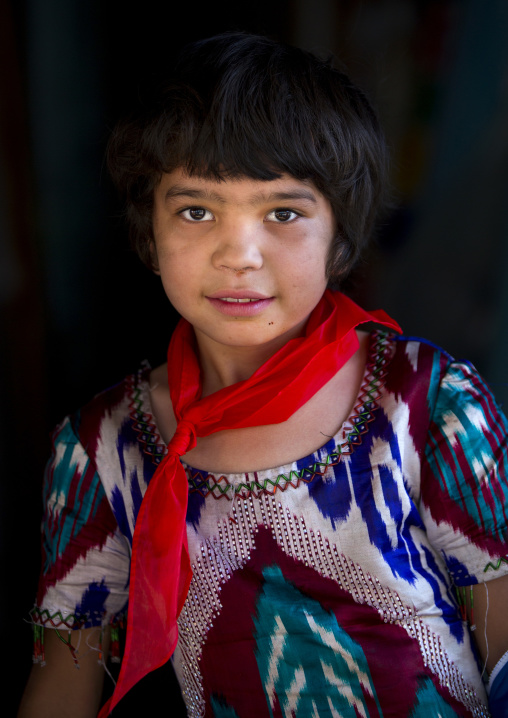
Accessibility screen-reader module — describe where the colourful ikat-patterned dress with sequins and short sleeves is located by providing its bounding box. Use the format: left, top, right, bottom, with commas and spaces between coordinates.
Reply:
34, 332, 508, 718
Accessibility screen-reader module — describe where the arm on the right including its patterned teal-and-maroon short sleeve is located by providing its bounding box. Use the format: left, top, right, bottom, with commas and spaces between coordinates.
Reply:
422, 362, 508, 718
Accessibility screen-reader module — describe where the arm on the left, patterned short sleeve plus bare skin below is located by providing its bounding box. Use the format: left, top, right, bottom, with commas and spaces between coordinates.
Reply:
18, 420, 129, 718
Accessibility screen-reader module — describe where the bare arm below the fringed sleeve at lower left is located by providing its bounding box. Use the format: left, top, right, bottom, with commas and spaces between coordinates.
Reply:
18, 628, 109, 718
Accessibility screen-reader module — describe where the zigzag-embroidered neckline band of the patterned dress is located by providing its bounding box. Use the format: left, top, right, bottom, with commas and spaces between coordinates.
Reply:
126, 330, 394, 501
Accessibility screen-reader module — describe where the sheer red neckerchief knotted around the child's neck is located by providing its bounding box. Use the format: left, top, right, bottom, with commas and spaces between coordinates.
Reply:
99, 290, 401, 718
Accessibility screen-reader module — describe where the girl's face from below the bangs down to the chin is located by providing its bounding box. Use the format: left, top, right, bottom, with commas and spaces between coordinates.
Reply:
153, 169, 335, 357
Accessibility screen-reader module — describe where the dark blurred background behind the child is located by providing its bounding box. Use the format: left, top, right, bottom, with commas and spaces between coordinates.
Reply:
0, 0, 508, 715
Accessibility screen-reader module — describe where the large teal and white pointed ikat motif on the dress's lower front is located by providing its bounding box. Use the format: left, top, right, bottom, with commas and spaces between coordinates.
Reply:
254, 565, 382, 718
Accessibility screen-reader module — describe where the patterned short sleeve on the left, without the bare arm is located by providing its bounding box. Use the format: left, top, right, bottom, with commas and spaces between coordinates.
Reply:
32, 418, 130, 628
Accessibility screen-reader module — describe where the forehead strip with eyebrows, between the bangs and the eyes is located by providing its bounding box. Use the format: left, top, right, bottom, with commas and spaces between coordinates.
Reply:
155, 169, 331, 208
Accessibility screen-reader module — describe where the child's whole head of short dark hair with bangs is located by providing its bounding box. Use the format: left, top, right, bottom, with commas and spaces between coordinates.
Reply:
108, 33, 386, 284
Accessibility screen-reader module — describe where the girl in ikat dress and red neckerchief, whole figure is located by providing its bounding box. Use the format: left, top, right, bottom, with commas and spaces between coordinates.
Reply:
20, 34, 508, 718
